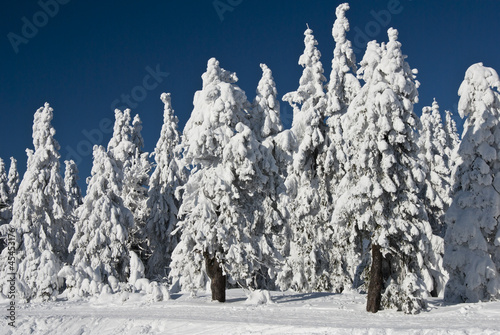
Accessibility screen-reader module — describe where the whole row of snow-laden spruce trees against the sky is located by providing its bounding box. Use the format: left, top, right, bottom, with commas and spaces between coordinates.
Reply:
0, 4, 500, 313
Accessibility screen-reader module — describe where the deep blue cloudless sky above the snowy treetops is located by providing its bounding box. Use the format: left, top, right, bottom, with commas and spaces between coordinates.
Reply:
0, 0, 500, 192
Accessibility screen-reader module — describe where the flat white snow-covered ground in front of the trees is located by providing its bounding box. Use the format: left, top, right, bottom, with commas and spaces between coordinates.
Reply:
0, 289, 500, 335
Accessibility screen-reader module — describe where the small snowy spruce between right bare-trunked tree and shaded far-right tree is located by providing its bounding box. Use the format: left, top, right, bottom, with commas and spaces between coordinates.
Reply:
418, 100, 451, 236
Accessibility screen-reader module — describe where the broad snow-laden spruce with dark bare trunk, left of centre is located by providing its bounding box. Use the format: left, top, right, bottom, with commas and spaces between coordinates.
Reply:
170, 58, 272, 301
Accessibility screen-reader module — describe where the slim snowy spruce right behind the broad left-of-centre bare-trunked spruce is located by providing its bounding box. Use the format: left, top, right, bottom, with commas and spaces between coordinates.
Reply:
249, 64, 286, 289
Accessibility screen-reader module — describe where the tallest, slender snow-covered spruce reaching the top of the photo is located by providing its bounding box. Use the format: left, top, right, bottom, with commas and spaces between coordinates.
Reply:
318, 3, 360, 292
